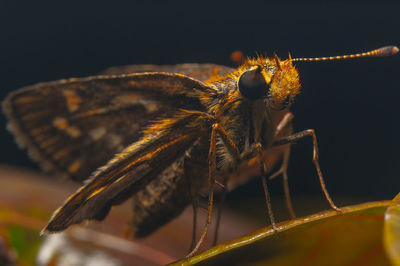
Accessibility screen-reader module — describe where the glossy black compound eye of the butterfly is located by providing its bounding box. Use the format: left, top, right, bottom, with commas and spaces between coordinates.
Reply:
238, 67, 268, 100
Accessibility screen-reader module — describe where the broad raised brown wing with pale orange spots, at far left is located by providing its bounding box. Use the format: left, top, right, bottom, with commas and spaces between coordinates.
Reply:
3, 73, 211, 180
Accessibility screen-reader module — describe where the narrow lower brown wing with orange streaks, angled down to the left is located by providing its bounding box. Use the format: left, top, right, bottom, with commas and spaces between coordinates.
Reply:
45, 126, 198, 232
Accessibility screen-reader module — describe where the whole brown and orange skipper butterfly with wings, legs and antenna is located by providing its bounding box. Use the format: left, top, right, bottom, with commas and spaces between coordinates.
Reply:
3, 47, 398, 256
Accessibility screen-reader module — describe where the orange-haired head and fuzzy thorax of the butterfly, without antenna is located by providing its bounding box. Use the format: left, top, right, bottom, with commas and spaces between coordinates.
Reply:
201, 58, 300, 169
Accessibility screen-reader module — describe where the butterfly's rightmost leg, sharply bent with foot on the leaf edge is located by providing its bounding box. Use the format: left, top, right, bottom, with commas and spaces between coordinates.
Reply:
274, 129, 341, 212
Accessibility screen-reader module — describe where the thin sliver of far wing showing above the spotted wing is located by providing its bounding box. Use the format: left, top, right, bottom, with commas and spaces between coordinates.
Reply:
102, 63, 235, 81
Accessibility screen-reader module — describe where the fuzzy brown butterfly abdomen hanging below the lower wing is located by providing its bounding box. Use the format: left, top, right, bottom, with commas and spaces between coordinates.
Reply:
130, 136, 208, 238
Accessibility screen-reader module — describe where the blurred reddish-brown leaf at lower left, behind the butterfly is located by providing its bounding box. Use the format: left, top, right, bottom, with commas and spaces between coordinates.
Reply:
0, 164, 259, 266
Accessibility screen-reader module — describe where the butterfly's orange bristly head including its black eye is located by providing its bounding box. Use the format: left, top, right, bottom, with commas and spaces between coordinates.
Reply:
238, 58, 300, 110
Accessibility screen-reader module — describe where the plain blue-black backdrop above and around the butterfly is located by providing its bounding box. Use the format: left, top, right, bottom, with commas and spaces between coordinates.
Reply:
0, 0, 400, 210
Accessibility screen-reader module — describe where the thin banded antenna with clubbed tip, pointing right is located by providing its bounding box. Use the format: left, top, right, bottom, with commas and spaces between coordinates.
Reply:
291, 46, 399, 62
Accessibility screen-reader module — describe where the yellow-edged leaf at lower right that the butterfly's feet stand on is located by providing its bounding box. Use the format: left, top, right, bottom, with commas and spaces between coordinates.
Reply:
176, 201, 400, 265
